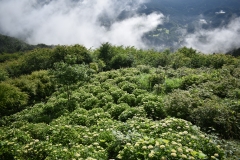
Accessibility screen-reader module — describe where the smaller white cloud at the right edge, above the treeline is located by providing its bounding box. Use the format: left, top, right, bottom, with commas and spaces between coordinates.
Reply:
184, 18, 240, 53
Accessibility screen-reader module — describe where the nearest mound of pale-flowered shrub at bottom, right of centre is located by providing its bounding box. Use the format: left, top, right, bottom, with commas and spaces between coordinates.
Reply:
117, 118, 224, 160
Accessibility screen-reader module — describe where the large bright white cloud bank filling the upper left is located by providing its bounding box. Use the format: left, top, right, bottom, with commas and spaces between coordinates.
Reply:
0, 0, 164, 48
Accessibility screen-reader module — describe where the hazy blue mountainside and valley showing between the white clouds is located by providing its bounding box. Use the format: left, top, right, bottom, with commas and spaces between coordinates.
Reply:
139, 0, 240, 50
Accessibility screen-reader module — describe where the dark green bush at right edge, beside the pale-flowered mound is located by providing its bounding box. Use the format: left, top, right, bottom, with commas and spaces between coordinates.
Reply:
191, 101, 240, 138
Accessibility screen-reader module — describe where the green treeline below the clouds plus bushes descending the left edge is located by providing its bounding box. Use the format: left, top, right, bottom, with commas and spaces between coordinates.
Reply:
0, 43, 240, 116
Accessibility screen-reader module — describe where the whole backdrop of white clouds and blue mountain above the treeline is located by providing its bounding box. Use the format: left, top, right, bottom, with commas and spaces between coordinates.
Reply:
0, 0, 240, 53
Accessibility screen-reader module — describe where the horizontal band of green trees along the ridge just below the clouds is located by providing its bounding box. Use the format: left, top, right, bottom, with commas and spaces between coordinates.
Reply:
0, 43, 239, 80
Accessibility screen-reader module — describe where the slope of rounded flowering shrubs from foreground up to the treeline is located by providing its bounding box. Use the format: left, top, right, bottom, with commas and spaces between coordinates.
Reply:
0, 64, 239, 160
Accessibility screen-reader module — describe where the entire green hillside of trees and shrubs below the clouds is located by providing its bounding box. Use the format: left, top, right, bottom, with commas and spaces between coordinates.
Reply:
0, 43, 240, 160
